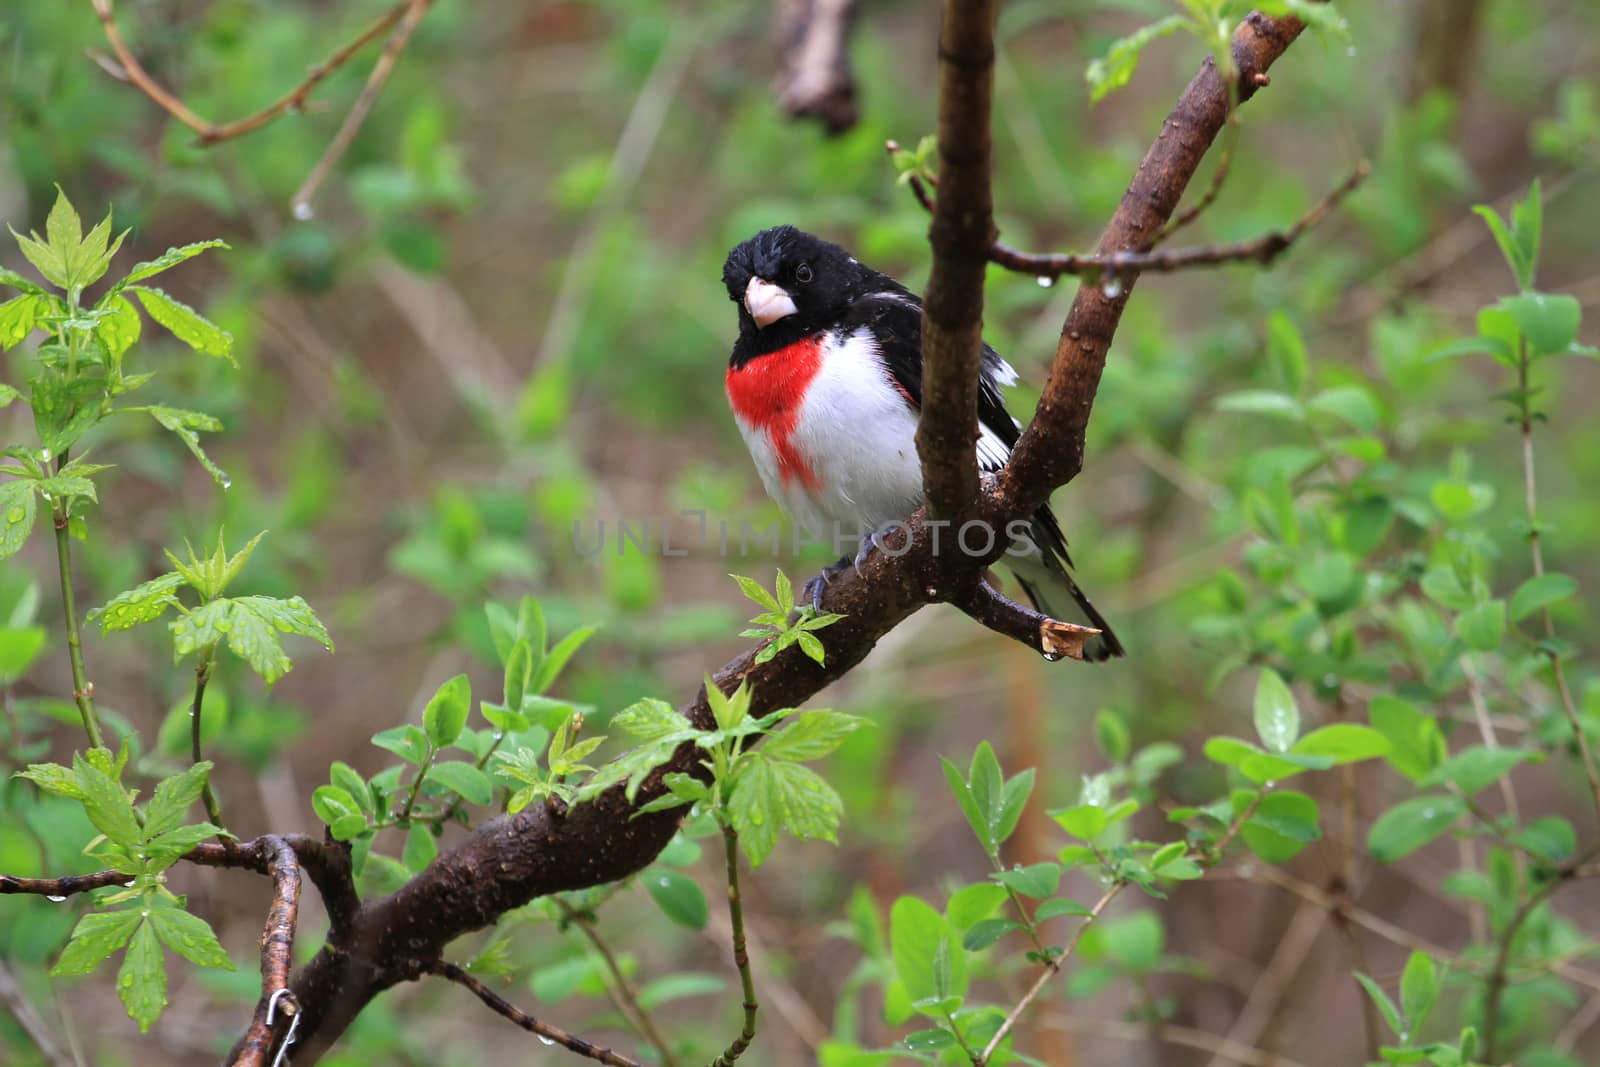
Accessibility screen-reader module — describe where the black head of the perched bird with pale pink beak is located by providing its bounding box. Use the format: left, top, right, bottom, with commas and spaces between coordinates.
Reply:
722, 226, 882, 350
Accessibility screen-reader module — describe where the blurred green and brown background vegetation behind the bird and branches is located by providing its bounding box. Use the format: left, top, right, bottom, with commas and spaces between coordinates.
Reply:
0, 0, 1600, 1065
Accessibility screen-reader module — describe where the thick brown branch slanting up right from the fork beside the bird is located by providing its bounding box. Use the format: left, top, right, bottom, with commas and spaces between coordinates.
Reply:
1000, 11, 1306, 514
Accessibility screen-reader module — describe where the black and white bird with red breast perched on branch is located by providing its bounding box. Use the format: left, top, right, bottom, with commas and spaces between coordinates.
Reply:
722, 226, 1123, 659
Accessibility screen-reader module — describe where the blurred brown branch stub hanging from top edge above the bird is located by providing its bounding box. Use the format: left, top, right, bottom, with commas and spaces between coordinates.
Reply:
776, 0, 859, 133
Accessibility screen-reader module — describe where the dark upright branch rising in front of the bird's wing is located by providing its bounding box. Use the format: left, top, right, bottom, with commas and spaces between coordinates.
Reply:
917, 0, 998, 523
